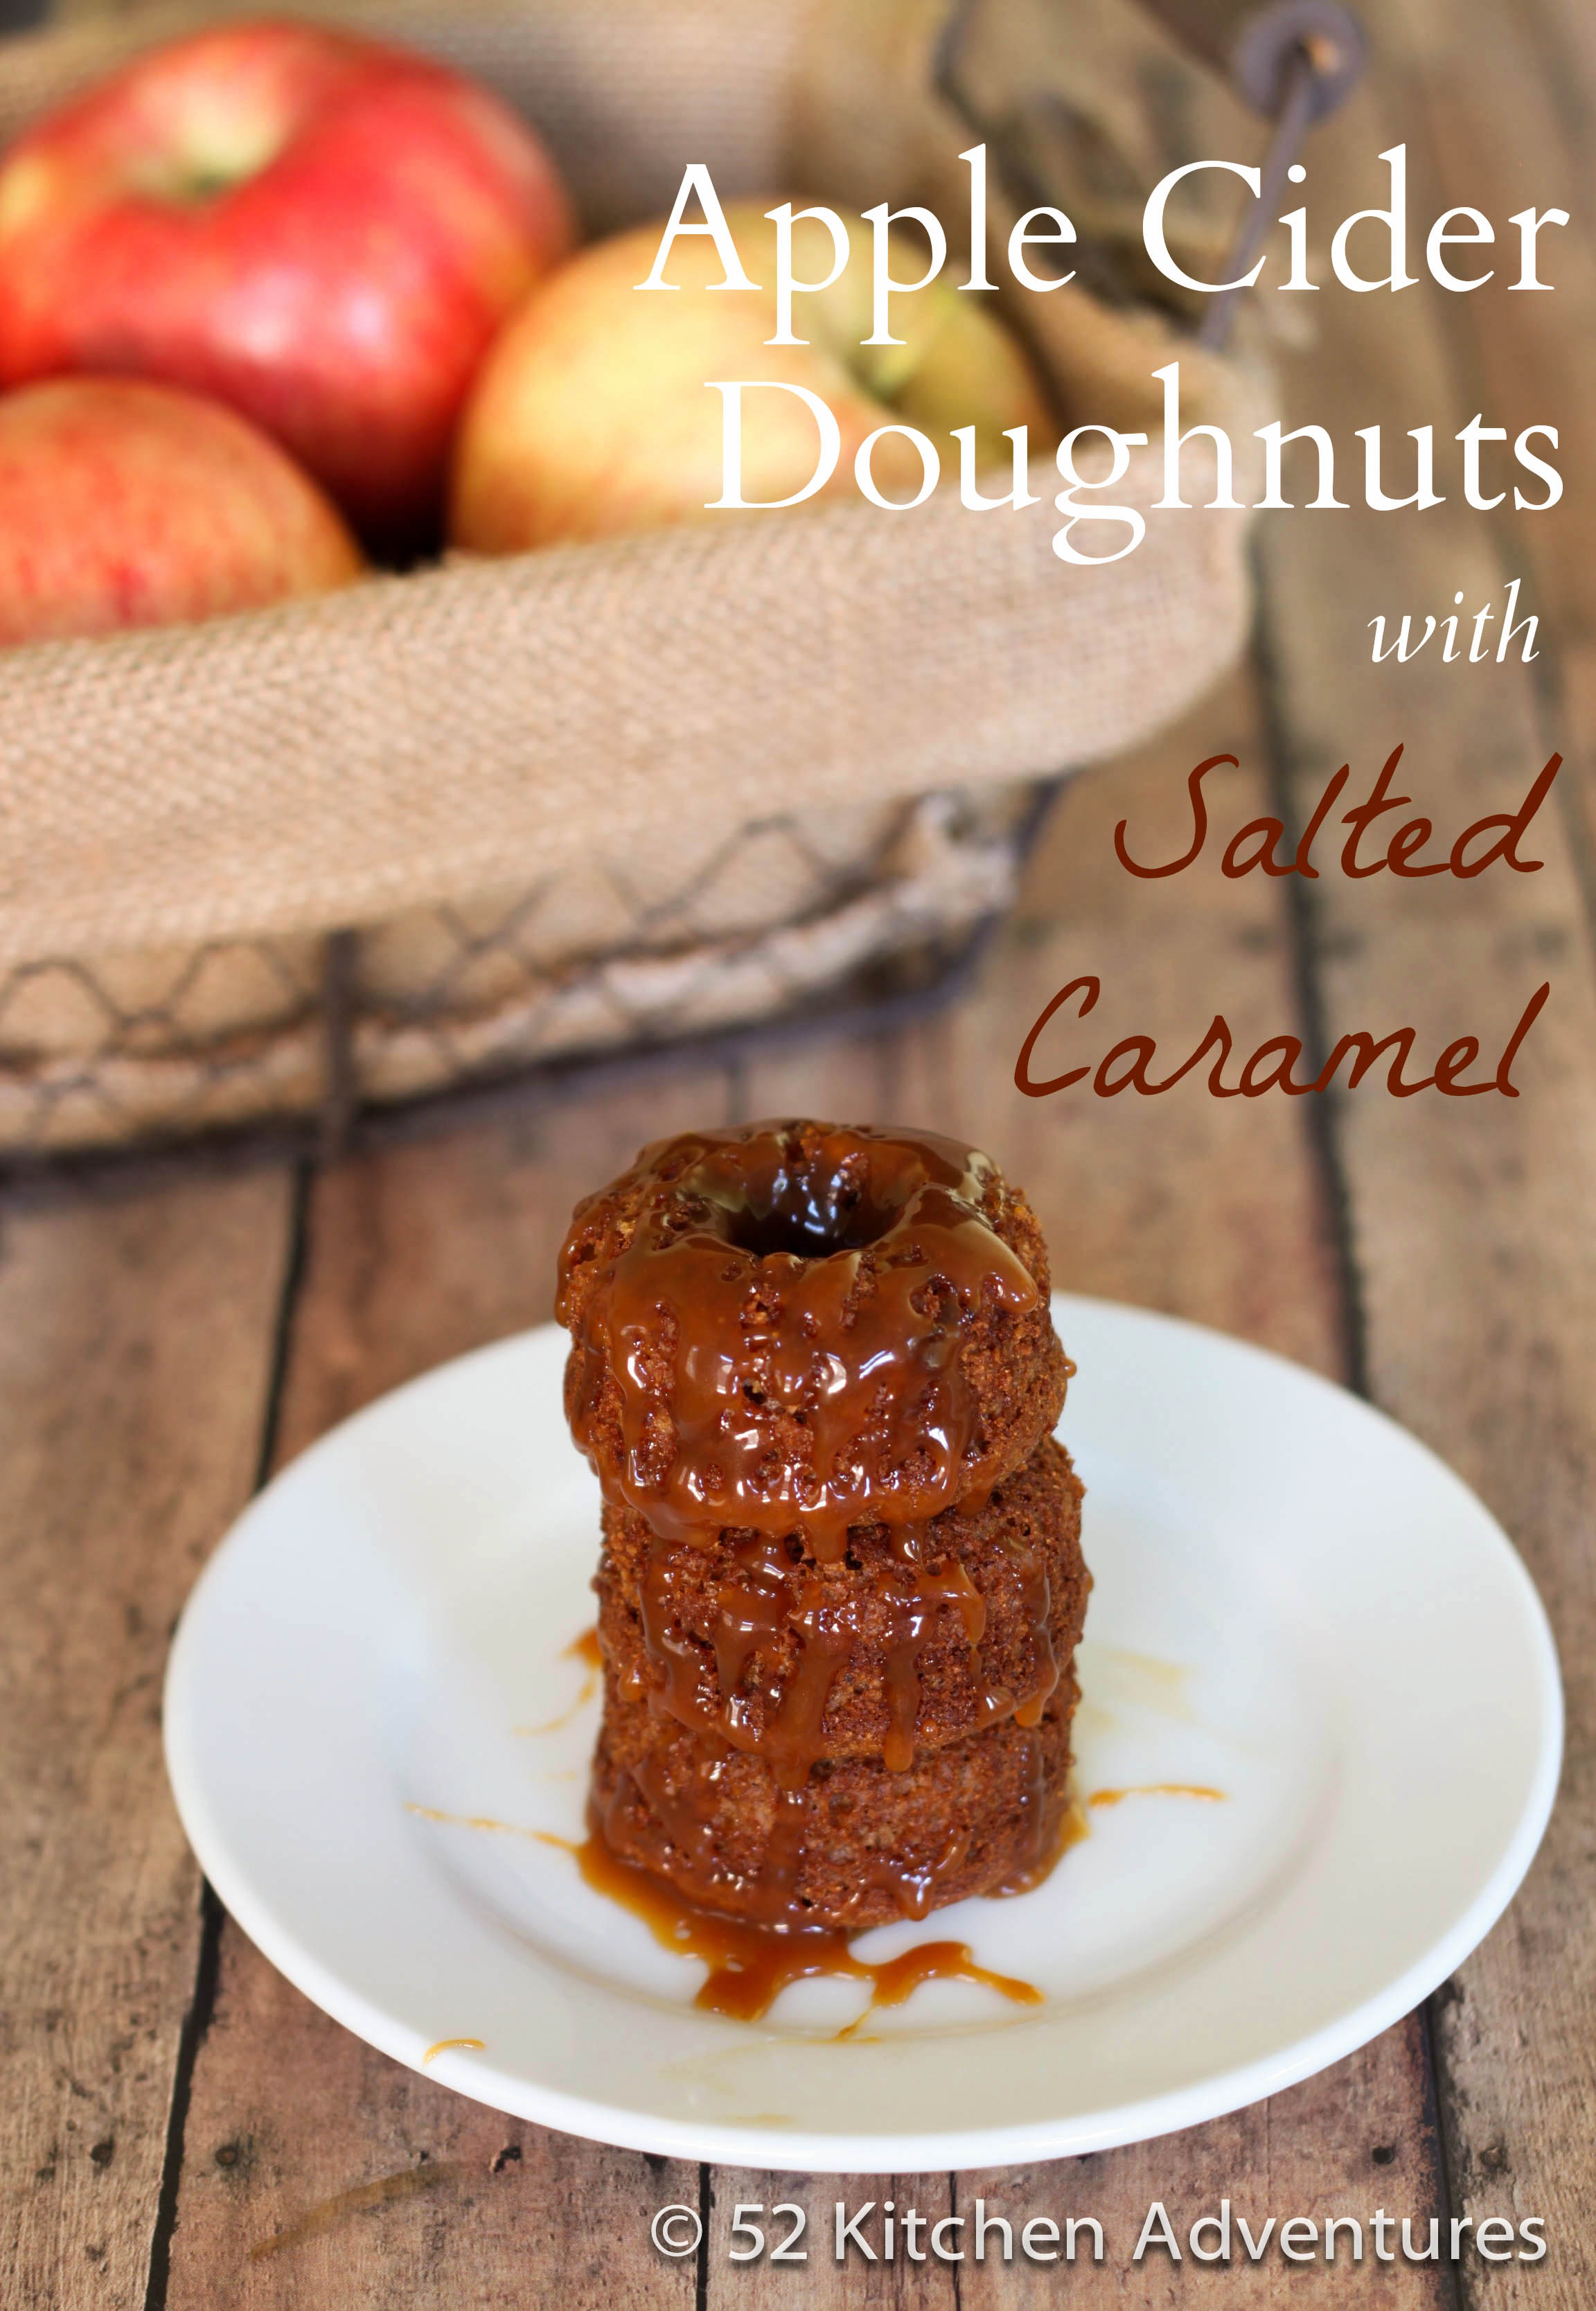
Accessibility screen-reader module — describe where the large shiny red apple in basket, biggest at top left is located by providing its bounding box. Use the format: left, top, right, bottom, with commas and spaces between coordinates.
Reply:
0, 21, 573, 545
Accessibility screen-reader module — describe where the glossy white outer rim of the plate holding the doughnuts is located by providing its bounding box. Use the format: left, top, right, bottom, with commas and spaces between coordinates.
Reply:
161, 1292, 1563, 2175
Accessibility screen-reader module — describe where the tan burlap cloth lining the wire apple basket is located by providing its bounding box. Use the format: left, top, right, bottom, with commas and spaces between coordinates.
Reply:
0, 0, 1257, 1144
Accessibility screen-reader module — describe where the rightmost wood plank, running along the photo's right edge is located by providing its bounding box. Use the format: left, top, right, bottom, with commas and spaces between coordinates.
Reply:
1264, 49, 1596, 2311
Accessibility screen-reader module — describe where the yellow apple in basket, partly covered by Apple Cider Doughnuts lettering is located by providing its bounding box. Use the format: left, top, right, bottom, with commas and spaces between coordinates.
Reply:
450, 199, 1049, 552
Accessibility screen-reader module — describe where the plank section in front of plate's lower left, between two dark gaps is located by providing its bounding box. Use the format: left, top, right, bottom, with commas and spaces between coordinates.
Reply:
166, 1920, 698, 2311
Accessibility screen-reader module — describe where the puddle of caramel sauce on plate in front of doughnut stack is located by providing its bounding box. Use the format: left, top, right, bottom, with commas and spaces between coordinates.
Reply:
578, 1830, 1042, 2038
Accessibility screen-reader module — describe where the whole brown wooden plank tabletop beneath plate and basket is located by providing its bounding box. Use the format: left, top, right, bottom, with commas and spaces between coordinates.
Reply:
0, 0, 1596, 2311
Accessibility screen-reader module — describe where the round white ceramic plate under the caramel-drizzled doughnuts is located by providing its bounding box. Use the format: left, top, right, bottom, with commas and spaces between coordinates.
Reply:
166, 1299, 1561, 2172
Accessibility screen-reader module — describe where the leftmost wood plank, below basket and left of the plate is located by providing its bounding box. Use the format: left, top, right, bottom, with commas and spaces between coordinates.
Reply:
0, 1169, 289, 2311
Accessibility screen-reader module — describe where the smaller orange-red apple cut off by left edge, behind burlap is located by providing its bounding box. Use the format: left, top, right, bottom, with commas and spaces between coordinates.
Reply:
0, 377, 362, 642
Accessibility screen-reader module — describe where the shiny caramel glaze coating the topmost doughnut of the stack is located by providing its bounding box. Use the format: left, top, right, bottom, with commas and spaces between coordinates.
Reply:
559, 1128, 1039, 1564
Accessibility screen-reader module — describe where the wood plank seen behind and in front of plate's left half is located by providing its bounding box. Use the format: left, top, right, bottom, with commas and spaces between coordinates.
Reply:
166, 1072, 727, 2311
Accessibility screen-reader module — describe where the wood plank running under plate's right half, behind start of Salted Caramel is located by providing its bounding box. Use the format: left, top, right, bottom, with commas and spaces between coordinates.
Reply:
725, 680, 1448, 2311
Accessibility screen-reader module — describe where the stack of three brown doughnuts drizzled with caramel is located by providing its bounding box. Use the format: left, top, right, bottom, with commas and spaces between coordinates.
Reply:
559, 1121, 1090, 1930
